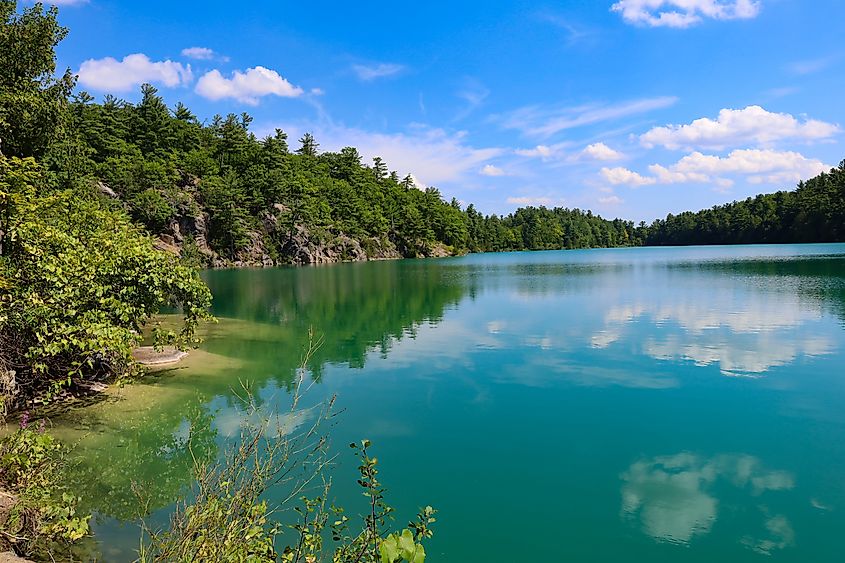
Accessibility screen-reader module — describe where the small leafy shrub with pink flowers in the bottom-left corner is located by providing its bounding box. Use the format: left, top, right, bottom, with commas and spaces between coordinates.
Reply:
0, 426, 89, 560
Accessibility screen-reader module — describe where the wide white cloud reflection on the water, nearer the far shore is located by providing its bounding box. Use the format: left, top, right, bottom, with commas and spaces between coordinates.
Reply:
590, 288, 835, 377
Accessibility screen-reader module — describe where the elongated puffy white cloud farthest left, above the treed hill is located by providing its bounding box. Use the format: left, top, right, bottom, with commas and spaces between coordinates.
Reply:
77, 53, 193, 92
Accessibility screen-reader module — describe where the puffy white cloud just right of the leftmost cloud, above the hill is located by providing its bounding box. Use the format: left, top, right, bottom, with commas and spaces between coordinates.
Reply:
196, 66, 303, 105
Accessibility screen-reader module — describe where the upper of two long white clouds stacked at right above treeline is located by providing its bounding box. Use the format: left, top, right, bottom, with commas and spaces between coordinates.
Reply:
640, 106, 840, 150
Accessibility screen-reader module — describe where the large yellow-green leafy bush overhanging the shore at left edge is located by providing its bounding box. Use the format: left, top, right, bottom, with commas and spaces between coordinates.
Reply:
0, 156, 211, 406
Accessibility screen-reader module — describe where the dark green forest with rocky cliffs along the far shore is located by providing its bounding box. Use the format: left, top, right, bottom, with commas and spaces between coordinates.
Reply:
54, 85, 845, 266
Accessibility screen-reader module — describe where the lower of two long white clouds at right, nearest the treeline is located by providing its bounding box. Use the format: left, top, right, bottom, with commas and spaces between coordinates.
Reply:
601, 149, 831, 188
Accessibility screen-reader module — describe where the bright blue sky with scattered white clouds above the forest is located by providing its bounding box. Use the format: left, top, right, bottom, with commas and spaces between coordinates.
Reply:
44, 0, 845, 221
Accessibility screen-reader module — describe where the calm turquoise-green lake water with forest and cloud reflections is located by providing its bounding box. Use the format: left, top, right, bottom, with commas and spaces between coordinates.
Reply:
51, 245, 845, 562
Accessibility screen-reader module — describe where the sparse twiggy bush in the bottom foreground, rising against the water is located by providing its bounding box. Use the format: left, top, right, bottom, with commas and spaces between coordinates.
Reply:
140, 352, 435, 563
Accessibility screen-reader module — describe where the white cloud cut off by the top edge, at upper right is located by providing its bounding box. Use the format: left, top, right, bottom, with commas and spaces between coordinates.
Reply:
611, 0, 762, 28
